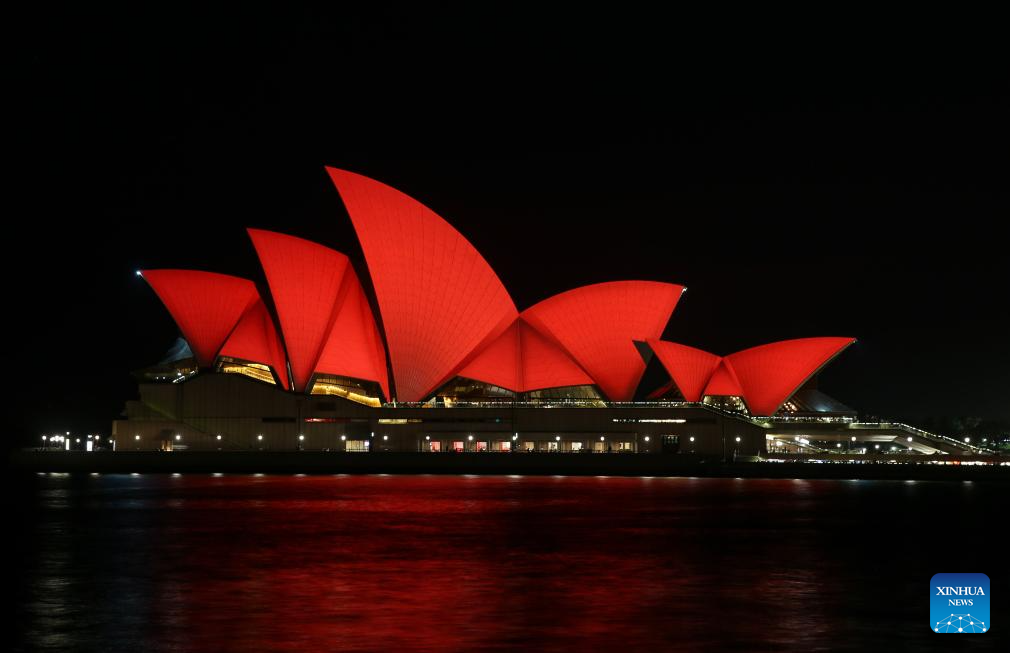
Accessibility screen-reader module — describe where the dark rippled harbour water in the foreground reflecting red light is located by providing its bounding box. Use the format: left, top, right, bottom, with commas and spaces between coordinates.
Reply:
11, 474, 993, 651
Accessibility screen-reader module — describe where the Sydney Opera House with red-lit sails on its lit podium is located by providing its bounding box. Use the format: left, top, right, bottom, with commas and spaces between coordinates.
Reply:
113, 169, 969, 457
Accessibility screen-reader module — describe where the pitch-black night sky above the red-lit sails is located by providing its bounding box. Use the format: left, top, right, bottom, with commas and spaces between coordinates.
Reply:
5, 6, 1010, 438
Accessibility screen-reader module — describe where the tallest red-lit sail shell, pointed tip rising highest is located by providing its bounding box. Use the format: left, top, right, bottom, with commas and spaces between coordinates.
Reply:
326, 168, 517, 401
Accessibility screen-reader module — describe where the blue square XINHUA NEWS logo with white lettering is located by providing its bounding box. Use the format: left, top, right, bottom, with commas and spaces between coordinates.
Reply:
929, 573, 990, 634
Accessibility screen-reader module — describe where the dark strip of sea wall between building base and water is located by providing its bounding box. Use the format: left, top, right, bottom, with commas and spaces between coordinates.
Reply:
9, 451, 1010, 482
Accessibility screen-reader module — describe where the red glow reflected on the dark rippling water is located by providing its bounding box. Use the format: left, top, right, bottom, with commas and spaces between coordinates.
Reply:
124, 476, 844, 651
